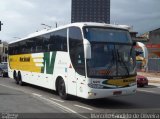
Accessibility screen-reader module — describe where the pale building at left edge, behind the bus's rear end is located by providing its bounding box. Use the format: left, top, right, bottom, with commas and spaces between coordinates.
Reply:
0, 40, 8, 63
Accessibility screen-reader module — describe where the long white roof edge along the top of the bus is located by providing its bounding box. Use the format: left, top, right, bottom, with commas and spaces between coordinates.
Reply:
9, 22, 128, 44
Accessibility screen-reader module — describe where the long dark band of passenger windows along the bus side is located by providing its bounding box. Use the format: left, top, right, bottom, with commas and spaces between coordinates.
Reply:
9, 29, 67, 55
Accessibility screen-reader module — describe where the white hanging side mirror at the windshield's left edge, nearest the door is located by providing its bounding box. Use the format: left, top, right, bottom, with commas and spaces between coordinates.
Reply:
83, 39, 91, 59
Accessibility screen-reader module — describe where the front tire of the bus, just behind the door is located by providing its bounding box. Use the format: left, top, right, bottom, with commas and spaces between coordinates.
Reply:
58, 79, 68, 100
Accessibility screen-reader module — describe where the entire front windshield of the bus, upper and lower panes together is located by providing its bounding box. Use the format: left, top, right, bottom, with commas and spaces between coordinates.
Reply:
85, 28, 136, 78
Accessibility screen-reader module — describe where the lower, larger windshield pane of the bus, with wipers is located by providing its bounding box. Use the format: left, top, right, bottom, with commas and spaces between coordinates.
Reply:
87, 43, 136, 78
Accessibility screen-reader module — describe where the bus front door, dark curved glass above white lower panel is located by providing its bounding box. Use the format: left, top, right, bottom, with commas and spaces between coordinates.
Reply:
68, 44, 85, 95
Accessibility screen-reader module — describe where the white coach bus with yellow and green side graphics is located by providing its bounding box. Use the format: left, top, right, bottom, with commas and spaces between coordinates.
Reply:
8, 22, 137, 99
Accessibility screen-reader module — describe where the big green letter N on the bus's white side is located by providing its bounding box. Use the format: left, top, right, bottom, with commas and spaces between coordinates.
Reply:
41, 52, 56, 74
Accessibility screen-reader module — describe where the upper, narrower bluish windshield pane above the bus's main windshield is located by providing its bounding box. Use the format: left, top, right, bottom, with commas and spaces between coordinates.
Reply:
84, 27, 132, 43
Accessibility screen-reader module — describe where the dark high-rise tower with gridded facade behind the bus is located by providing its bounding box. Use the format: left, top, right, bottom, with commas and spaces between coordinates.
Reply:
71, 0, 110, 23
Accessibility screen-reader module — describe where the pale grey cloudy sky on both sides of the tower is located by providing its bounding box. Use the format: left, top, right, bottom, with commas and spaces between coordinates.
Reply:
0, 0, 160, 41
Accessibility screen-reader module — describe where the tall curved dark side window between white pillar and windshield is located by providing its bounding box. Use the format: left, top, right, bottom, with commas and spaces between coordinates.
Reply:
69, 27, 85, 75
